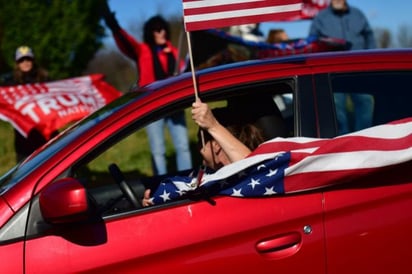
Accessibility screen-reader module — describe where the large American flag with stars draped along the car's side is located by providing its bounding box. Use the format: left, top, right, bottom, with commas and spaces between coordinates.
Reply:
146, 118, 412, 204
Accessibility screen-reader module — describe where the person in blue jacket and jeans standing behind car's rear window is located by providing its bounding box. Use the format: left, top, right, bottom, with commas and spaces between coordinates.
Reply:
309, 0, 376, 134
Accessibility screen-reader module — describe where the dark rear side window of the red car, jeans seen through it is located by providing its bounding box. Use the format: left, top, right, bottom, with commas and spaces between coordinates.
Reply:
331, 71, 412, 134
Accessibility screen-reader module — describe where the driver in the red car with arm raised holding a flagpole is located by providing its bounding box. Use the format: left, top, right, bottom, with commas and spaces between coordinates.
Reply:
142, 100, 264, 207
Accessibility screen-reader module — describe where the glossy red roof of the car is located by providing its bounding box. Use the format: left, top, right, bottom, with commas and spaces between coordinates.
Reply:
141, 49, 412, 97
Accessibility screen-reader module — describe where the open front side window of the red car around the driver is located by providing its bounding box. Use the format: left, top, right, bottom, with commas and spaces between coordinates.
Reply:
71, 80, 293, 216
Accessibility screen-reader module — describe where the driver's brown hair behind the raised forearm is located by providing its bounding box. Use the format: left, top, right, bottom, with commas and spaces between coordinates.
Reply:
198, 108, 264, 150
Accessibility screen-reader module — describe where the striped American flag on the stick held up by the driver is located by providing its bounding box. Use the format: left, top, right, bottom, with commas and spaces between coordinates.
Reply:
183, 0, 329, 31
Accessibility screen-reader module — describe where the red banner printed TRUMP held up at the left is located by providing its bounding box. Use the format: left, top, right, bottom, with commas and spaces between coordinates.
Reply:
0, 74, 121, 139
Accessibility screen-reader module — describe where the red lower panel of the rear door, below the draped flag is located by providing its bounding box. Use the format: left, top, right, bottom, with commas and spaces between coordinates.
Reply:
325, 174, 412, 274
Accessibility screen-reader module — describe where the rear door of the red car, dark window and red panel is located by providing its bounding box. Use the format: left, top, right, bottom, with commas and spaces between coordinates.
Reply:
315, 69, 412, 274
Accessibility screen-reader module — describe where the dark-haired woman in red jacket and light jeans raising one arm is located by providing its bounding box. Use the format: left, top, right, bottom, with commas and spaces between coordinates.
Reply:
101, 1, 192, 175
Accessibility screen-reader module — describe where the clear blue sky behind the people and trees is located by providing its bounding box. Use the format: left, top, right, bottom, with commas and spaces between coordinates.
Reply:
105, 0, 412, 47
